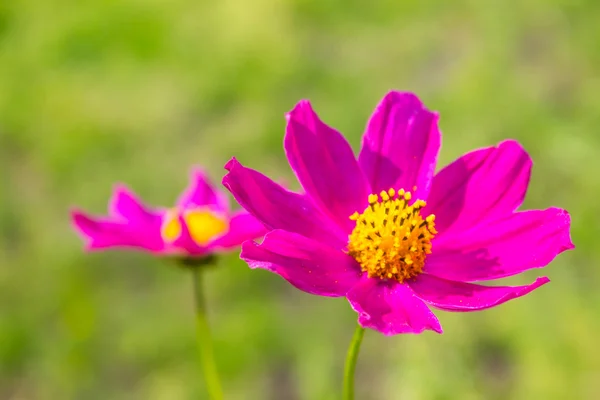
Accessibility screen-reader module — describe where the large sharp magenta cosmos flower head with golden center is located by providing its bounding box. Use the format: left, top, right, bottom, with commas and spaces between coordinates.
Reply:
223, 92, 573, 335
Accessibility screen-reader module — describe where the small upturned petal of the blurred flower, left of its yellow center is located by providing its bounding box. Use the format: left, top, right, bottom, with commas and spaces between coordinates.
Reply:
108, 184, 160, 224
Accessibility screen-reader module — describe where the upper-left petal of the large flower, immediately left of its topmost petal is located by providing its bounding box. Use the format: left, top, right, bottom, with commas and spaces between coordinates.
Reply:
284, 100, 369, 232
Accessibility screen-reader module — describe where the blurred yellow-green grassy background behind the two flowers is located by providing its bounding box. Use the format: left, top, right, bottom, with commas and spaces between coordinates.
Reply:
0, 0, 600, 400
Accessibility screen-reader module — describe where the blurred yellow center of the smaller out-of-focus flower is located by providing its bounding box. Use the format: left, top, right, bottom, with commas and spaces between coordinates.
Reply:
161, 208, 229, 246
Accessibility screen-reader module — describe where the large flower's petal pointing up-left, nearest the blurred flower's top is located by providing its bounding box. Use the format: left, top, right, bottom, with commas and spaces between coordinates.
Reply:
223, 158, 348, 248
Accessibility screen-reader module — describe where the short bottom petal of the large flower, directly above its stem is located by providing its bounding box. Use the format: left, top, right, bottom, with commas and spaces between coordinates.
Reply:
346, 278, 442, 335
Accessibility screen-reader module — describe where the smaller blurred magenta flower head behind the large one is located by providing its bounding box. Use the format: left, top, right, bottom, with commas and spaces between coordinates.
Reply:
71, 168, 265, 258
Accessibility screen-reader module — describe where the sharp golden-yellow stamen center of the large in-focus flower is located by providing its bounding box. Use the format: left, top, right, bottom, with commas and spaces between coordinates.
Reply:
348, 189, 437, 283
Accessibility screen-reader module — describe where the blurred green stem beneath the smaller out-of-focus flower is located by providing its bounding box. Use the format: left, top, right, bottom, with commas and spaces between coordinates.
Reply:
191, 266, 223, 400
